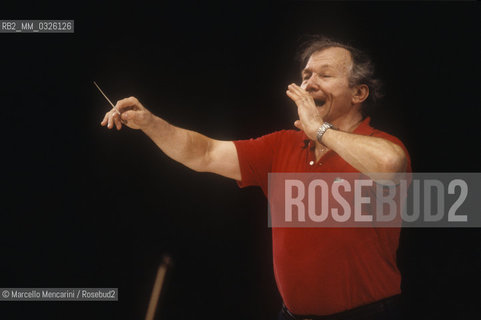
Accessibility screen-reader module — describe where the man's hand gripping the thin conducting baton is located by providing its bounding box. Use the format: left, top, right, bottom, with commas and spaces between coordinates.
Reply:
100, 97, 154, 130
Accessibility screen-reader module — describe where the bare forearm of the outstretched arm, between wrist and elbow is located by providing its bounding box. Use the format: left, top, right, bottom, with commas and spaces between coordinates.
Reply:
142, 116, 211, 171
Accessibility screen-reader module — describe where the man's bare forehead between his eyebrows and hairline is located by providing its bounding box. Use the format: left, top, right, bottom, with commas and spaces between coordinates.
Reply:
304, 47, 352, 72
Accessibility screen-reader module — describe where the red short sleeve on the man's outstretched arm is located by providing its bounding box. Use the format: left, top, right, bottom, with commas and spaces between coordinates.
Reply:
234, 132, 280, 190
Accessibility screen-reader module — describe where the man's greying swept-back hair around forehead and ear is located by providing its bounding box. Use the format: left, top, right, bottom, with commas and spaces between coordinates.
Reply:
298, 35, 383, 115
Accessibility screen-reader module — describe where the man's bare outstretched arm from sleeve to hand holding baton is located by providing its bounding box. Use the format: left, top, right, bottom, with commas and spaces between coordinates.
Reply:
101, 97, 241, 180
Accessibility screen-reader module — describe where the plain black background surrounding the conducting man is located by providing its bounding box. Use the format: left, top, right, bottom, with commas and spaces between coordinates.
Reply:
0, 1, 481, 319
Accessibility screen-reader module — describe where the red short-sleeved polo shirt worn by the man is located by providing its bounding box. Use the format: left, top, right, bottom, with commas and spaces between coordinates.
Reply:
234, 118, 411, 315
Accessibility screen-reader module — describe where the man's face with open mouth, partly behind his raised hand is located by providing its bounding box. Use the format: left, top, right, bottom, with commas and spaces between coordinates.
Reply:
301, 47, 354, 122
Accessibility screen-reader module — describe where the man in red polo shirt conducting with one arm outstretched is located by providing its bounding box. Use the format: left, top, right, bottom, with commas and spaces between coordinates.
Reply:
101, 37, 410, 319
